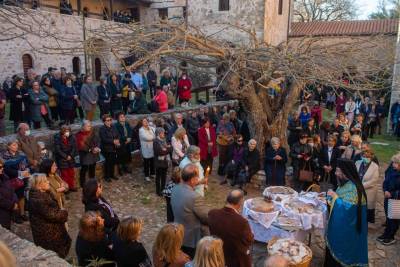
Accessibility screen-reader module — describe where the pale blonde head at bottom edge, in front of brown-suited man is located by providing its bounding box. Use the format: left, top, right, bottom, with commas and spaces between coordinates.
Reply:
185, 236, 225, 267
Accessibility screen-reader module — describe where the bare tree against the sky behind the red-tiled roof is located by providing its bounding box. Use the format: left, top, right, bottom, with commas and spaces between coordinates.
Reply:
293, 0, 357, 22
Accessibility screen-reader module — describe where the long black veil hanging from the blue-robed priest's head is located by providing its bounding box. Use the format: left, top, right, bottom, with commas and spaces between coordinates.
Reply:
337, 158, 367, 233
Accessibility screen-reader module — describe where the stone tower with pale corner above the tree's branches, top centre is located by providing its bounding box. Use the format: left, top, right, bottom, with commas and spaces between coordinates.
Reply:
187, 0, 293, 45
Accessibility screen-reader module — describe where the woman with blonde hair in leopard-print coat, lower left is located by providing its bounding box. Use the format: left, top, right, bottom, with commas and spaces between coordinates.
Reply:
28, 173, 71, 258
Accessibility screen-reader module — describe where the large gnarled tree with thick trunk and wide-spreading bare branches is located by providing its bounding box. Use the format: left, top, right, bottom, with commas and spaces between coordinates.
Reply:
0, 4, 394, 151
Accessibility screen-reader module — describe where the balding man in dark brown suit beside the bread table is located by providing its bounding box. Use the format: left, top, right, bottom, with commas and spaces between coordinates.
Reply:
208, 189, 254, 267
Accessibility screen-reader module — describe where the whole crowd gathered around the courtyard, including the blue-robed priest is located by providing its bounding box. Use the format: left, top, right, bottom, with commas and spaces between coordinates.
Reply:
0, 73, 400, 267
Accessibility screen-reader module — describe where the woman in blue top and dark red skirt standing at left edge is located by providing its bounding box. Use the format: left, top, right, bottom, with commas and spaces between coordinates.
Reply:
2, 140, 31, 223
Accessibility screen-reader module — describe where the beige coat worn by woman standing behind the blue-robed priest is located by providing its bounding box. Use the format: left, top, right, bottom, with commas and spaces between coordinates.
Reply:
356, 160, 382, 209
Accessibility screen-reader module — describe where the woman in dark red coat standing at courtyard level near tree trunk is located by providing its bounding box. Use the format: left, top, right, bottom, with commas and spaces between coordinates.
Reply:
197, 117, 218, 173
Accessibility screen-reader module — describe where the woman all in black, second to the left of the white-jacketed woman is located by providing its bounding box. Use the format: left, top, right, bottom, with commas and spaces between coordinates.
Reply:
99, 114, 121, 182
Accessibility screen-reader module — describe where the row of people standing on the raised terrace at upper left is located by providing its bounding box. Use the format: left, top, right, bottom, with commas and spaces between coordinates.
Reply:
0, 67, 192, 136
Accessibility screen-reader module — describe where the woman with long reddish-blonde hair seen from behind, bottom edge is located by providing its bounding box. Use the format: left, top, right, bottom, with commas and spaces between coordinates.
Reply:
153, 223, 190, 267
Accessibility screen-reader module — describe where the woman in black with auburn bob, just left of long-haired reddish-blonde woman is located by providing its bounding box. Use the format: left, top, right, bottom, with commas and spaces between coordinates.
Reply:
112, 217, 151, 267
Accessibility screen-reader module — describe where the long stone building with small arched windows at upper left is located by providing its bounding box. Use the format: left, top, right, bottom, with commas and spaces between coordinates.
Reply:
0, 0, 185, 82
